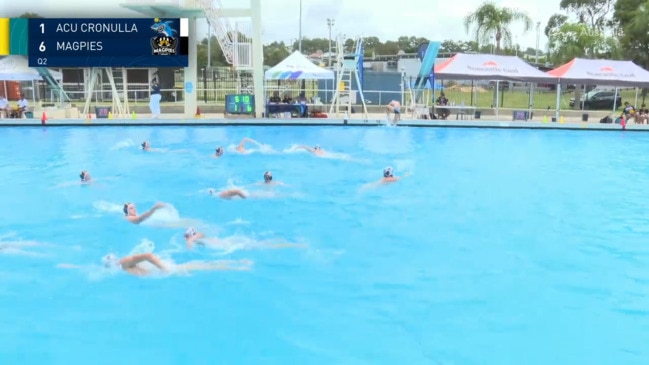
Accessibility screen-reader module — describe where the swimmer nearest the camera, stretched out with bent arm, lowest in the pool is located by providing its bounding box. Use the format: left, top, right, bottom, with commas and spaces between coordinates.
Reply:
57, 253, 252, 276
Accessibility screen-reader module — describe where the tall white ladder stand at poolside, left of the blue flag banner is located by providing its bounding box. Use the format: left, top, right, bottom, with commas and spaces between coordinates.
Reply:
329, 37, 367, 119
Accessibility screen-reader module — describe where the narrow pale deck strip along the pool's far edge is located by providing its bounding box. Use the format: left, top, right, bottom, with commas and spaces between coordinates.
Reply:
0, 114, 649, 132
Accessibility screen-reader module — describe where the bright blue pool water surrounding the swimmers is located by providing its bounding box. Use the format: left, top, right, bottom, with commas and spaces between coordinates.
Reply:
0, 127, 649, 365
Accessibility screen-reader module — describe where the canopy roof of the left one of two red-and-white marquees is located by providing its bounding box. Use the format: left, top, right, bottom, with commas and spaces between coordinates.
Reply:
435, 53, 557, 83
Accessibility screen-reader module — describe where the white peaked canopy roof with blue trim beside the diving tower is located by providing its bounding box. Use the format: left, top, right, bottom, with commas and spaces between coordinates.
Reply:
264, 51, 334, 80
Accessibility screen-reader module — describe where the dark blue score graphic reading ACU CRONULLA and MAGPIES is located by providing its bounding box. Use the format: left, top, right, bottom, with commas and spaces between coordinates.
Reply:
0, 18, 189, 67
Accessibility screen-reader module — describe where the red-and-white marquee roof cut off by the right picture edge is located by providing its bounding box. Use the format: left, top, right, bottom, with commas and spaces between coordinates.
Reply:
547, 58, 649, 87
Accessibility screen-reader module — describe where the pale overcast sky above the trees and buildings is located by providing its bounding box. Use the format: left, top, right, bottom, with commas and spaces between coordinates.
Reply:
0, 0, 559, 48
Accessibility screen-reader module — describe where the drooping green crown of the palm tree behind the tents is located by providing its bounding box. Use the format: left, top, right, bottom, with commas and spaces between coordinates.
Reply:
464, 2, 532, 52
